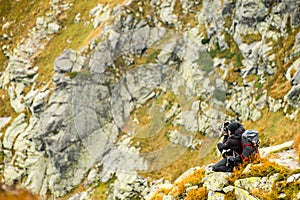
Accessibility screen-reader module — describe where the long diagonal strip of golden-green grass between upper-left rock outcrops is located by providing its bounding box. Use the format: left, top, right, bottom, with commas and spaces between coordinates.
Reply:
34, 0, 98, 86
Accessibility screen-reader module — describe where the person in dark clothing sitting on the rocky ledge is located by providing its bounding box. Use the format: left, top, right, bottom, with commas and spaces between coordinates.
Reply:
212, 122, 245, 172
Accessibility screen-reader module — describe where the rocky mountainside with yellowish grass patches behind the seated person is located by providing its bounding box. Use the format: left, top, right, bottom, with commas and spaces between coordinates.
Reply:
0, 0, 300, 199
